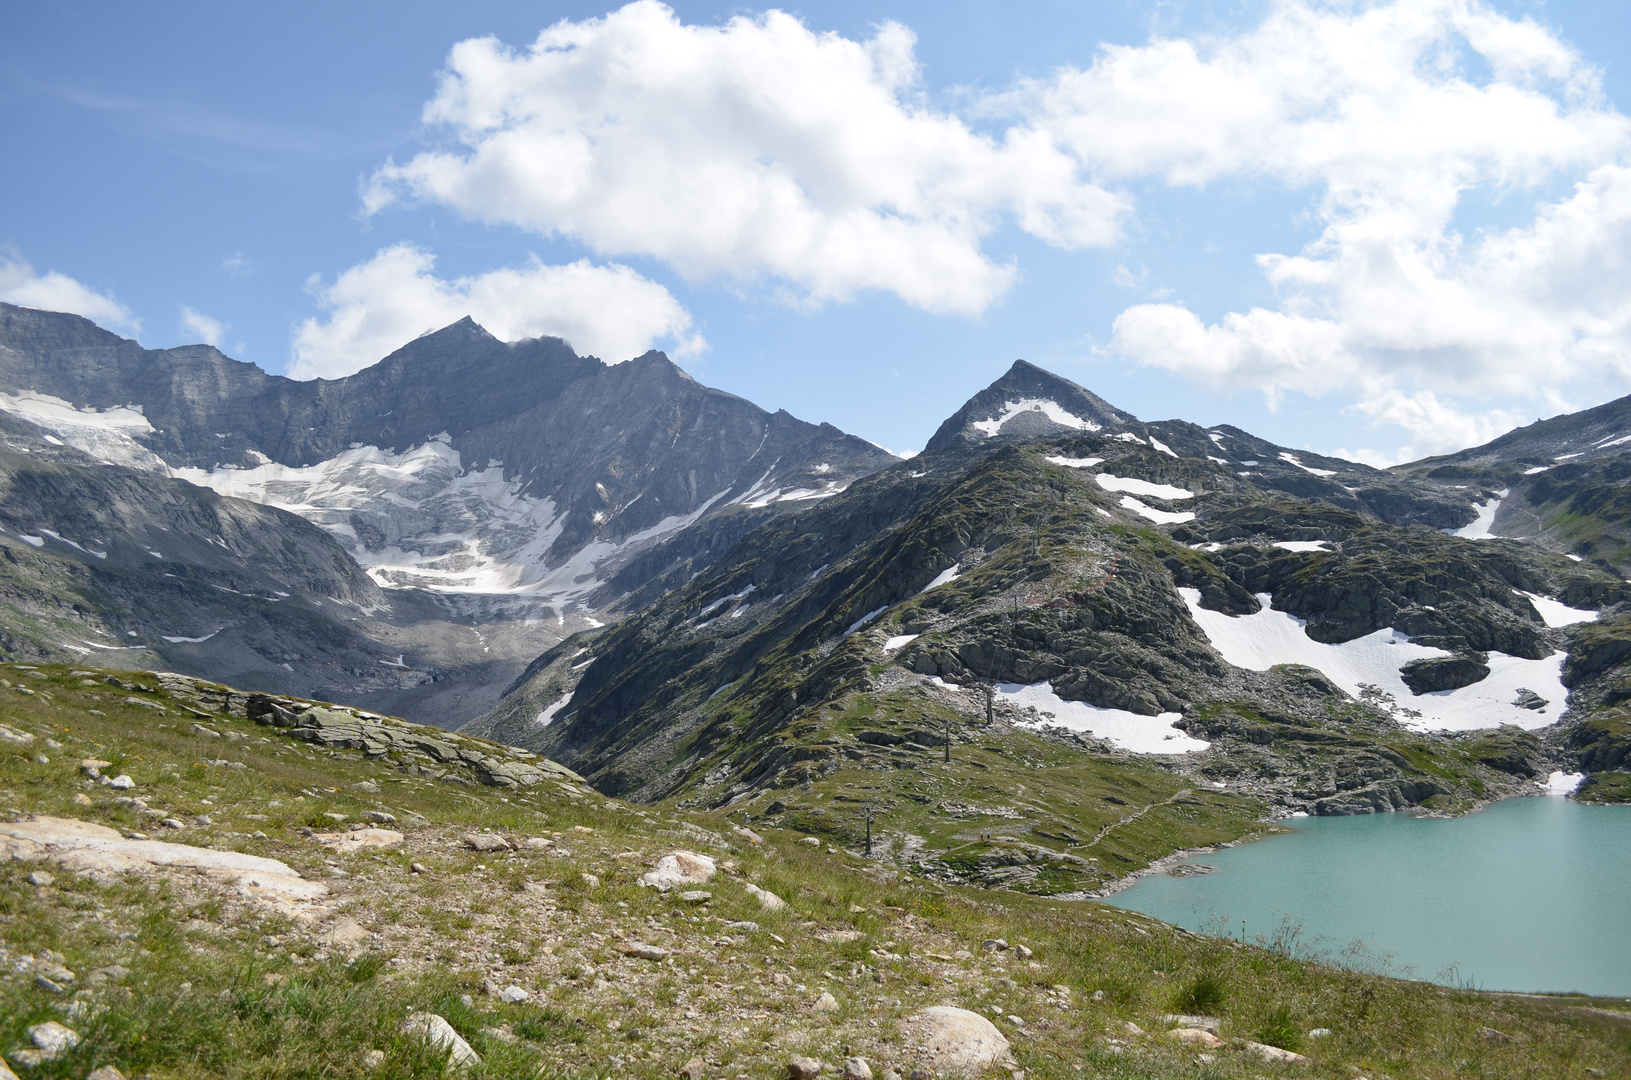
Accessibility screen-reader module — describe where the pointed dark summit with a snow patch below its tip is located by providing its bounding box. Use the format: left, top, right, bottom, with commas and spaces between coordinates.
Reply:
923, 361, 1137, 450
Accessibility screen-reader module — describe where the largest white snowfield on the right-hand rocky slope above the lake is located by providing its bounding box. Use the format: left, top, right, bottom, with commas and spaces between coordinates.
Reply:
1178, 589, 1567, 731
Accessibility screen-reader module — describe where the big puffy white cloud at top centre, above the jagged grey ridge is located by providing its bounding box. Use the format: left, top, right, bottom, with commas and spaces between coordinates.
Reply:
364, 0, 1129, 313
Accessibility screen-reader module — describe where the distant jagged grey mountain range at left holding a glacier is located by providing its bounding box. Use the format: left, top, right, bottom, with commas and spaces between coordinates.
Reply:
0, 305, 894, 724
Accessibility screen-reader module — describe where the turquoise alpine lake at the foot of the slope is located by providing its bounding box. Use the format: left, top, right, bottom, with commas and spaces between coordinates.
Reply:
1106, 796, 1631, 997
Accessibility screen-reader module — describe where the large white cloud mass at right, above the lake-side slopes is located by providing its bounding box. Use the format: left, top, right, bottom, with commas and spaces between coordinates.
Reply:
1082, 0, 1631, 450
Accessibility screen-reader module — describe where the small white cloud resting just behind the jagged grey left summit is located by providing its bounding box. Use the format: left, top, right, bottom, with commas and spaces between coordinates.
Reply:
289, 243, 706, 378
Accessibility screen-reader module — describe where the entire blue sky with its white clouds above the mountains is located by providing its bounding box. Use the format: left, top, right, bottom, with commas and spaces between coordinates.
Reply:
0, 0, 1631, 462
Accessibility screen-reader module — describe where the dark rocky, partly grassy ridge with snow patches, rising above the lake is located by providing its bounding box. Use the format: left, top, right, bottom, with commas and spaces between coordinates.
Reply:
466, 369, 1631, 891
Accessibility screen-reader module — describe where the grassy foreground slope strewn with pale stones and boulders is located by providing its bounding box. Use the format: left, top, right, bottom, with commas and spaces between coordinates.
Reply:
0, 667, 1631, 1080
